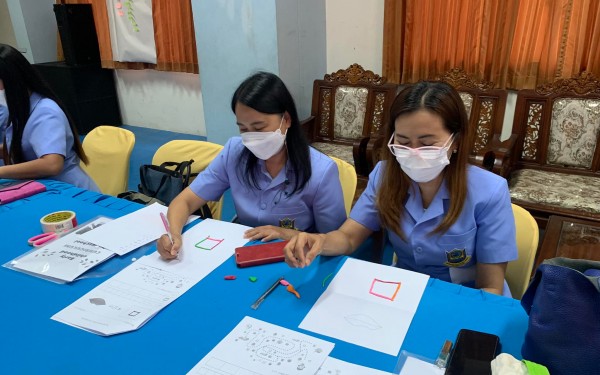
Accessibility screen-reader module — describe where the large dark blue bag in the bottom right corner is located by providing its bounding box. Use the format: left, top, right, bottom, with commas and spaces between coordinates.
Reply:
521, 258, 600, 375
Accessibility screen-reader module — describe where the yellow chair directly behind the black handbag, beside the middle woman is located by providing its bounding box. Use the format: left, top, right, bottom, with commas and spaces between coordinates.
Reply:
152, 140, 223, 220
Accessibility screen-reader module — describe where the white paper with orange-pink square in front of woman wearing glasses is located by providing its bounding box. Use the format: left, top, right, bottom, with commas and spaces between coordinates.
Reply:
300, 258, 429, 356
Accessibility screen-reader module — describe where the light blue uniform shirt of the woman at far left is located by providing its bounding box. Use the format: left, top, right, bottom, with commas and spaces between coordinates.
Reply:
5, 93, 100, 192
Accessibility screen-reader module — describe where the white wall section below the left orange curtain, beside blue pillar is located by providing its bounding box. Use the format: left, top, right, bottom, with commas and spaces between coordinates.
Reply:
115, 70, 206, 136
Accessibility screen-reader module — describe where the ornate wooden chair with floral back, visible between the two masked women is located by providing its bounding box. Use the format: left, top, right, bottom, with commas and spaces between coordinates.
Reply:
302, 64, 398, 178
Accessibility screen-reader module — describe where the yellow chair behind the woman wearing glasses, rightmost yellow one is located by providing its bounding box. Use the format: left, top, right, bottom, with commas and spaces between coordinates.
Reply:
505, 204, 540, 299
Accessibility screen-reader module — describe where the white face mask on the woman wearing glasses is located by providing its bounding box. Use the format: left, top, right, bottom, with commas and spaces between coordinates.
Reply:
388, 134, 454, 182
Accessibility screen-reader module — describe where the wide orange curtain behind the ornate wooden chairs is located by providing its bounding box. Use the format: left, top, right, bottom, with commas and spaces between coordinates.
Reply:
383, 0, 600, 89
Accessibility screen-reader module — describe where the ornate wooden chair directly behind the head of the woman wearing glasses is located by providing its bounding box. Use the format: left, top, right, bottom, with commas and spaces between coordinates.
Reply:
365, 68, 508, 172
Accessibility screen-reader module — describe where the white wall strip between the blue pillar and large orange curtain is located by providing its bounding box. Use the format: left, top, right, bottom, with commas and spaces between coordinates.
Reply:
326, 0, 384, 74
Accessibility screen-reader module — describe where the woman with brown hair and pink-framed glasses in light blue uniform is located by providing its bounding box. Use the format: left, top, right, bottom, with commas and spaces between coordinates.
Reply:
285, 82, 517, 296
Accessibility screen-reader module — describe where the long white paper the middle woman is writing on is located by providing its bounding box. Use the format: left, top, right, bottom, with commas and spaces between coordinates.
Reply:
52, 219, 249, 336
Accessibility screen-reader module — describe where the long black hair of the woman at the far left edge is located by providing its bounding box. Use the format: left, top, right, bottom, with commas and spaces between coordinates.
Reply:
0, 44, 88, 164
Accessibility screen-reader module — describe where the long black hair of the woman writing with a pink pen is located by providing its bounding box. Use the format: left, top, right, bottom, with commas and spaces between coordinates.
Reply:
231, 72, 312, 194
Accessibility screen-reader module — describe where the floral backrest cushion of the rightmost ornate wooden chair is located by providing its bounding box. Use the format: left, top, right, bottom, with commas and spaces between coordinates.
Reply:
548, 98, 600, 169
